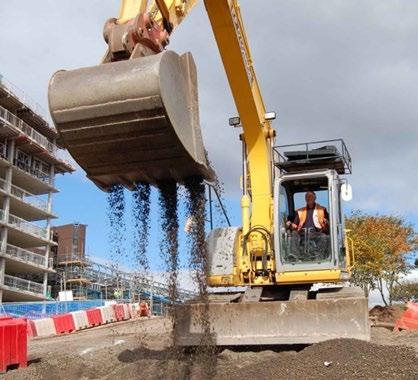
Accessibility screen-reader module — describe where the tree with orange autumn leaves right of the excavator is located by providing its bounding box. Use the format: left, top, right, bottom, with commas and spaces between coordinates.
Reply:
346, 211, 418, 305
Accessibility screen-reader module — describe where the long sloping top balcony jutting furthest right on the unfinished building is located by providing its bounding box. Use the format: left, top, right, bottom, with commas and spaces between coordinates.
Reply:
0, 106, 74, 172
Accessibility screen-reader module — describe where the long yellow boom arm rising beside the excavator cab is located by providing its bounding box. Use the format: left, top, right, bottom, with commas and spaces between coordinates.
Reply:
205, 0, 273, 231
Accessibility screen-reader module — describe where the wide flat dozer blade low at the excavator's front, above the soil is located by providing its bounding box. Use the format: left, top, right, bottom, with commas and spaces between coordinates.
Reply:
175, 297, 370, 346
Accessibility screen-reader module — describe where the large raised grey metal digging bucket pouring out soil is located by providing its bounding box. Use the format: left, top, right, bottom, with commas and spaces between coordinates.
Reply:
48, 51, 212, 191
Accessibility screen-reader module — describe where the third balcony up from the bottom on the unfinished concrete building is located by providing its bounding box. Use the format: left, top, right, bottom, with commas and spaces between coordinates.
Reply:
0, 210, 56, 248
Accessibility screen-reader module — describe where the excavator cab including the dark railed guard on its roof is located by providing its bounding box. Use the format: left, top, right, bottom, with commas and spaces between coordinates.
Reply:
275, 140, 352, 277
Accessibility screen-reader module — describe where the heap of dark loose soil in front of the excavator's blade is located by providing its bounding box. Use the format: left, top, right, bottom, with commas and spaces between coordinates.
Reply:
218, 339, 418, 379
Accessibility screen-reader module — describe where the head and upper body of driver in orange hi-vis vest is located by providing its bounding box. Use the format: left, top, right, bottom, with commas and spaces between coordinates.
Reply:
286, 191, 329, 233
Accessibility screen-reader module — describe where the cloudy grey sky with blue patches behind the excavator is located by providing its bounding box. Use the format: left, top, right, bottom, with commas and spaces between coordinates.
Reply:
0, 0, 418, 274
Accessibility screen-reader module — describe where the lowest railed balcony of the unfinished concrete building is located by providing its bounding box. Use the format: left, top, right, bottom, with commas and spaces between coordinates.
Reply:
0, 274, 46, 302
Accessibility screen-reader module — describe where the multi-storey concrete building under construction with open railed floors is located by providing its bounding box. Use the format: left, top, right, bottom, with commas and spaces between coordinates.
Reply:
0, 75, 74, 302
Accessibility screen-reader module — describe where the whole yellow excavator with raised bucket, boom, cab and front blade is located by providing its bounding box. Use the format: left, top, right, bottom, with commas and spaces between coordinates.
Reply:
49, 0, 370, 346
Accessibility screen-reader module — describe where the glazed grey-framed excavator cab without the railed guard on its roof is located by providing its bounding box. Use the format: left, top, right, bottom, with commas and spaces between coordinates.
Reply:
276, 170, 345, 272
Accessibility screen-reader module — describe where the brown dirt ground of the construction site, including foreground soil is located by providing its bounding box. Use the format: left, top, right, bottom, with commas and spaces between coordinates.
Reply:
3, 318, 418, 380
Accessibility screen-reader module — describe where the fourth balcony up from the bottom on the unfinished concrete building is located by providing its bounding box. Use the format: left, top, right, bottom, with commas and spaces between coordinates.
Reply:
0, 178, 56, 221
